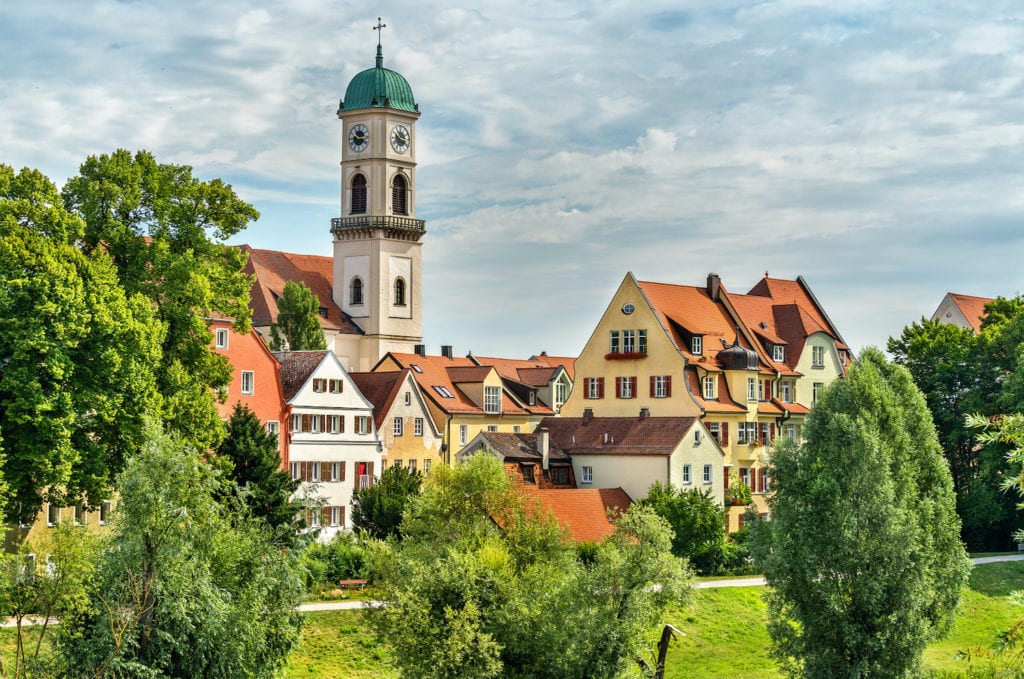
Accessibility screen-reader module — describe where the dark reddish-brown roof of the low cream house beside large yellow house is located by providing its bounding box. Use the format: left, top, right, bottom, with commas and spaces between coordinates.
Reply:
539, 417, 697, 456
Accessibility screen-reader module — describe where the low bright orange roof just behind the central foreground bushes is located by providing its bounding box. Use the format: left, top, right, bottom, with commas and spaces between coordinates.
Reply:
522, 487, 633, 543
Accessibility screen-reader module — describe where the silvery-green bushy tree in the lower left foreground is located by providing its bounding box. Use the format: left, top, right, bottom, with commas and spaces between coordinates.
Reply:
61, 433, 302, 677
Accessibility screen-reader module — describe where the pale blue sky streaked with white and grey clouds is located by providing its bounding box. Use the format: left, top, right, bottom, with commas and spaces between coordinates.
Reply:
0, 0, 1024, 357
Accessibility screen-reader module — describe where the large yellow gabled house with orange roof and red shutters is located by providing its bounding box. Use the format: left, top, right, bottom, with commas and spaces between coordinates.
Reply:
561, 273, 849, 529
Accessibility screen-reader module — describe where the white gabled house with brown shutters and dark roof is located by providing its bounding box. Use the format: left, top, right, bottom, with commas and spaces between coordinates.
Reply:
274, 350, 381, 541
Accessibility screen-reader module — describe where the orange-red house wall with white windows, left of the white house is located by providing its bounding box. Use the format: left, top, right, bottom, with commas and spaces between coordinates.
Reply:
209, 319, 288, 469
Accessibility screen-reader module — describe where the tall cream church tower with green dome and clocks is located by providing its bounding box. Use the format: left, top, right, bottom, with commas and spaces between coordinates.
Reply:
331, 19, 426, 370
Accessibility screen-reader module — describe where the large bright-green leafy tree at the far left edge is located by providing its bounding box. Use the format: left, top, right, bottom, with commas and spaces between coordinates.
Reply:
0, 166, 164, 522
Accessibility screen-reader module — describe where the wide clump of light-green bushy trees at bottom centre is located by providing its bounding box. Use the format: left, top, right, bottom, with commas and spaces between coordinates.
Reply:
369, 456, 686, 679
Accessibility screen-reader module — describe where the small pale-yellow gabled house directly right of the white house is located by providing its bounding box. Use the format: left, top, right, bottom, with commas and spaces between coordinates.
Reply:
349, 370, 443, 473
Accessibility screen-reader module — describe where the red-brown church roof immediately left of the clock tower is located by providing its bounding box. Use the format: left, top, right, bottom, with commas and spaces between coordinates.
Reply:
240, 245, 362, 335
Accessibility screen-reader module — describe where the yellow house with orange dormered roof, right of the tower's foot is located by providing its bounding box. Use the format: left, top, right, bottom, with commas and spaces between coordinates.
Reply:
374, 346, 555, 463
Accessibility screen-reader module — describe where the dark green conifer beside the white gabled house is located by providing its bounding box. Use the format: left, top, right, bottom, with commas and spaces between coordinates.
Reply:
211, 404, 305, 545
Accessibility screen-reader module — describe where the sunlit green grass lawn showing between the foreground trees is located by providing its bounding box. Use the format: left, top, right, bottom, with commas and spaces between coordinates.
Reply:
286, 561, 1024, 679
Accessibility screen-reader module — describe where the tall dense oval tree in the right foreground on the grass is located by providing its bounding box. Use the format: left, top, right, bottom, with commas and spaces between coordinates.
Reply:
752, 349, 969, 678
